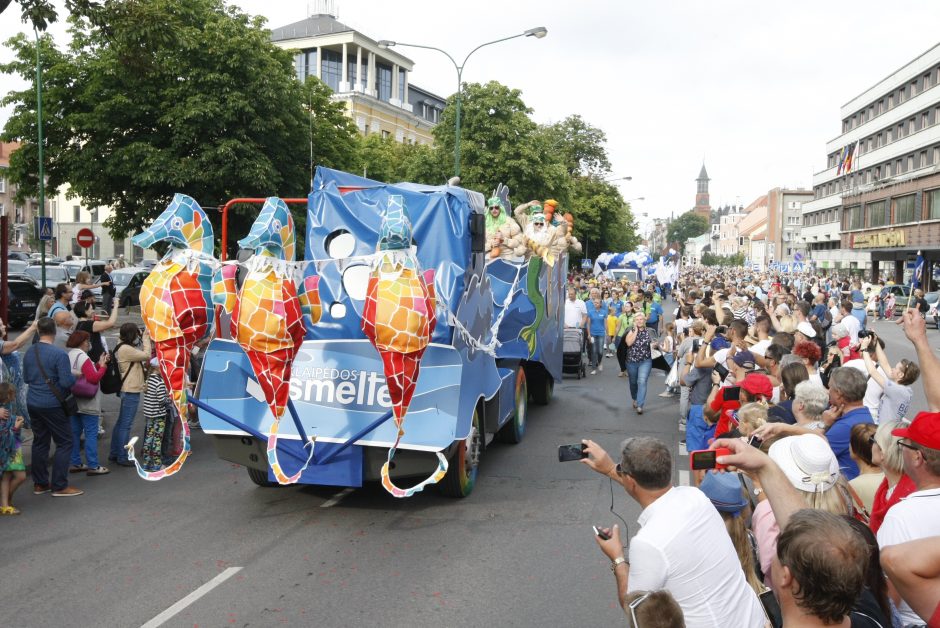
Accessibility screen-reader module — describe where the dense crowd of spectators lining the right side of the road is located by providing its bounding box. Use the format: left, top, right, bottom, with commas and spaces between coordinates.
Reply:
573, 269, 940, 628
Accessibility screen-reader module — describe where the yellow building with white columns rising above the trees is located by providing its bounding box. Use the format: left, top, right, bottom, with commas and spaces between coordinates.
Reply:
271, 14, 445, 144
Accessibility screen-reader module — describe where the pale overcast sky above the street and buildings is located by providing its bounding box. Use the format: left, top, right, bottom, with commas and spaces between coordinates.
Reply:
0, 0, 940, 223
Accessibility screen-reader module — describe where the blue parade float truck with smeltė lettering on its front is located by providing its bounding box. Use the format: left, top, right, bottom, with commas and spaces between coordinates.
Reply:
191, 168, 567, 497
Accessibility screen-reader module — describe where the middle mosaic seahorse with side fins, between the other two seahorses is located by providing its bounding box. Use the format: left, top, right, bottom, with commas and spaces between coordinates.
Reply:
212, 197, 322, 484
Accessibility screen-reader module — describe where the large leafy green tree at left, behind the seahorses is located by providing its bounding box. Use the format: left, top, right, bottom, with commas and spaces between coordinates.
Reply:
0, 0, 359, 250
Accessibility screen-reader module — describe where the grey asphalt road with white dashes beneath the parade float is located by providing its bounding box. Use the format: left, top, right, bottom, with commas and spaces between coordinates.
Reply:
0, 310, 924, 628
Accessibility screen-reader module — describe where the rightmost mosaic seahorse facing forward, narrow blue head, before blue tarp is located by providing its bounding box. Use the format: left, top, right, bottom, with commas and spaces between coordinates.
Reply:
362, 195, 447, 497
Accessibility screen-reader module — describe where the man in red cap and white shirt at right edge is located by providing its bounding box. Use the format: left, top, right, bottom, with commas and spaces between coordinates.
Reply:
878, 412, 940, 626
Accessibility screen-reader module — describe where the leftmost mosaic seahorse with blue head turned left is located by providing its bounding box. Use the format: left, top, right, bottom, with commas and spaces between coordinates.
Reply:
126, 194, 216, 480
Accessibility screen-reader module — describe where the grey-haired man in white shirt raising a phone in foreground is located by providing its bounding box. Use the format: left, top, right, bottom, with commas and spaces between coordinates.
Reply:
582, 436, 764, 628
